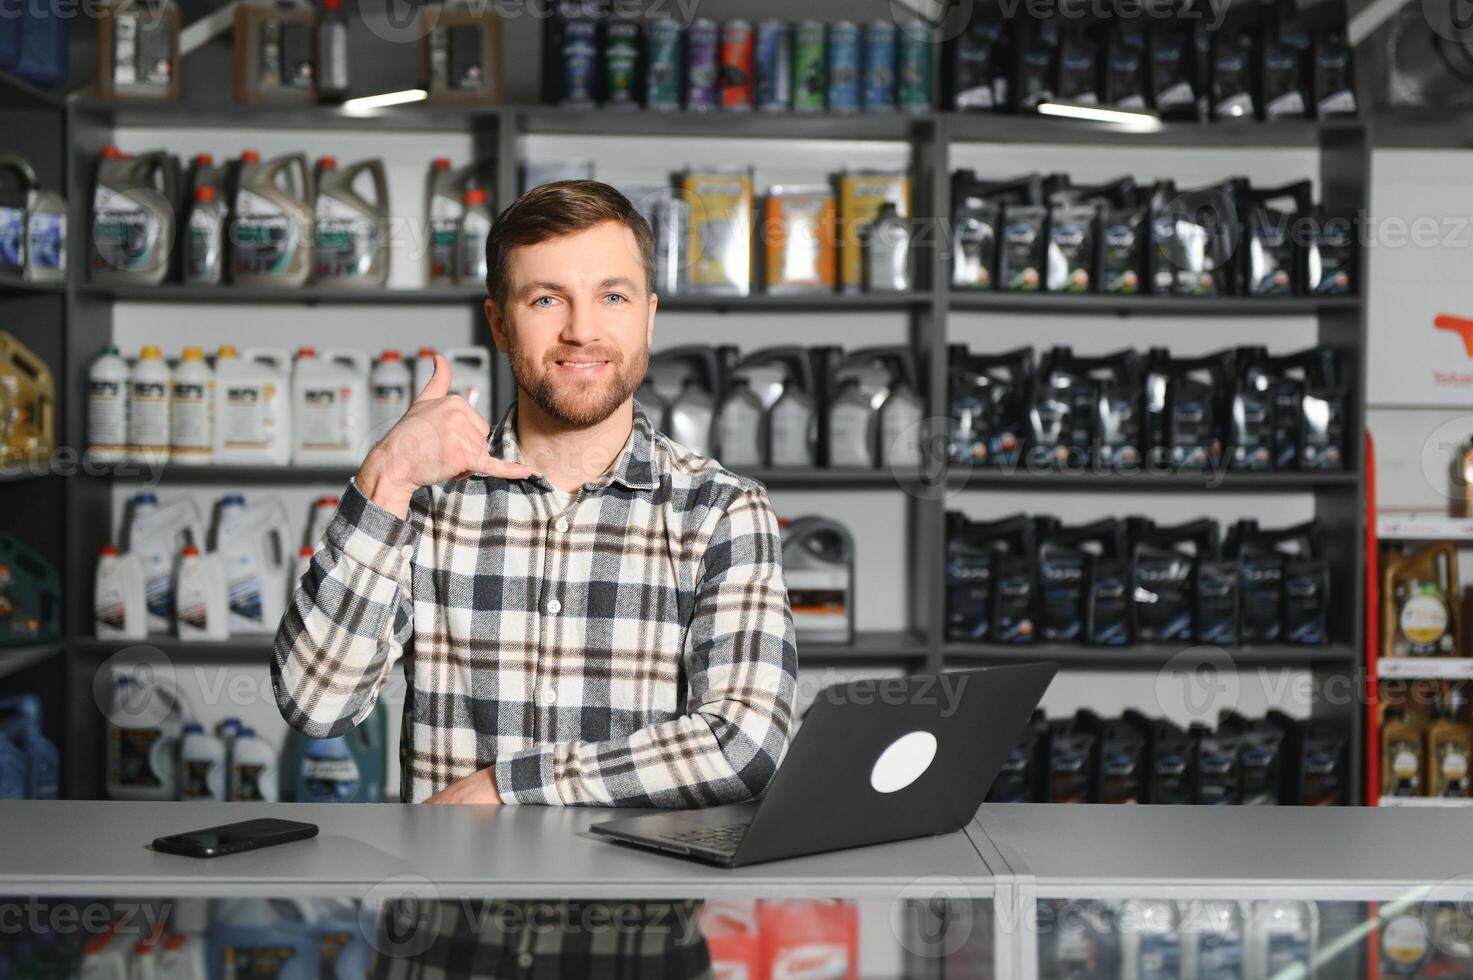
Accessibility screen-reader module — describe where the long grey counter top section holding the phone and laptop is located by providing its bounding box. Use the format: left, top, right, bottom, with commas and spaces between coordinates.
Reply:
0, 800, 993, 899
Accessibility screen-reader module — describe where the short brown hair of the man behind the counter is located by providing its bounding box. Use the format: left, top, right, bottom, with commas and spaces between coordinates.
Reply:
486, 180, 654, 308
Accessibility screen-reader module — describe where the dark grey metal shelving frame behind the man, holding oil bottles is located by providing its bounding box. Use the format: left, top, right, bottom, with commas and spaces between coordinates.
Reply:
0, 24, 1368, 799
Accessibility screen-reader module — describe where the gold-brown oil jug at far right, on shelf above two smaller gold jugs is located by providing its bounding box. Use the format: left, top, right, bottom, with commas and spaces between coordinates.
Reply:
1382, 541, 1463, 657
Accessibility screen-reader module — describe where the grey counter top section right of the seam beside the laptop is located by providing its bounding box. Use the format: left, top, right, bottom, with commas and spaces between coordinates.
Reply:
968, 803, 1473, 902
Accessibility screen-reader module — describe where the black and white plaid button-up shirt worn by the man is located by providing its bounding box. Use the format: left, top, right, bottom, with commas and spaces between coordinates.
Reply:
271, 404, 797, 806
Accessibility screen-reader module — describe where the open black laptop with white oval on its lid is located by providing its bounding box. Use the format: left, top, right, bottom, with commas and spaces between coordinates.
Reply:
589, 662, 1059, 868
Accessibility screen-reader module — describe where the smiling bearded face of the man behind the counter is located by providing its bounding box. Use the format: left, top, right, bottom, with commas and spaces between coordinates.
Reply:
486, 221, 655, 427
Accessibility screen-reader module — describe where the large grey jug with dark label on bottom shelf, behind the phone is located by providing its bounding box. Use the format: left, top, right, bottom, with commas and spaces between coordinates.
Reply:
106, 673, 190, 800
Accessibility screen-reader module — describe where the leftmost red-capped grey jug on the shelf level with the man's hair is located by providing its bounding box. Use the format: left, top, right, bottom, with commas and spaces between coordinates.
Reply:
90, 146, 180, 286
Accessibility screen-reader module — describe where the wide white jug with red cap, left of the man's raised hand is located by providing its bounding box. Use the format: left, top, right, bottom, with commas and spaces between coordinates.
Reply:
292, 348, 370, 466
